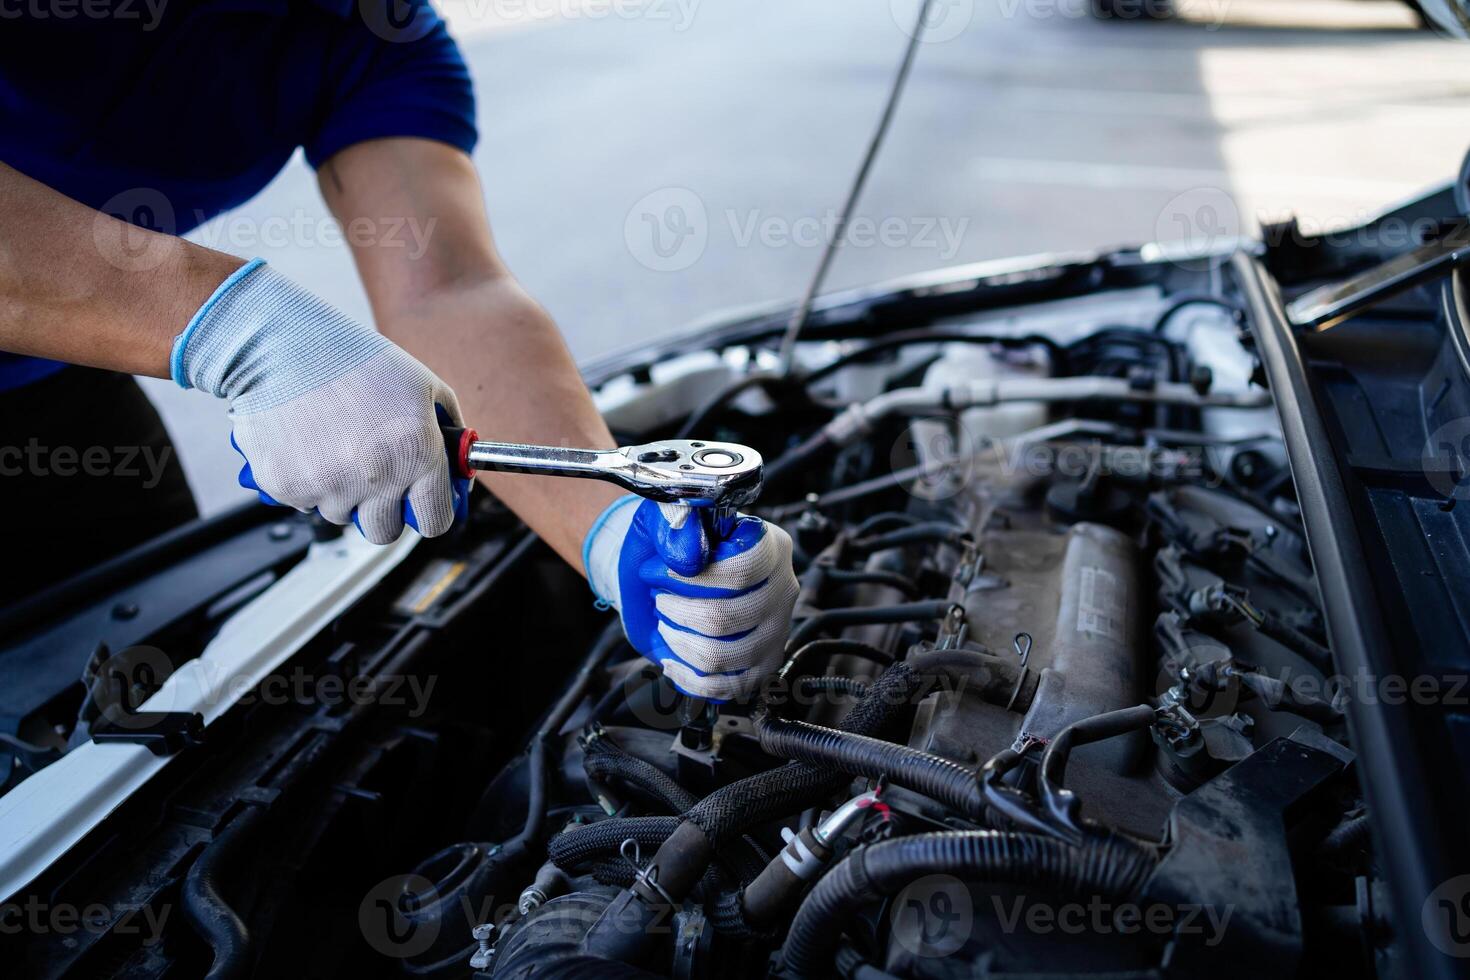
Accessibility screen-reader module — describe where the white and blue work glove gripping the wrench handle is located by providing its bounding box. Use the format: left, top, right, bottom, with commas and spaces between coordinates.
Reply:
169, 259, 470, 545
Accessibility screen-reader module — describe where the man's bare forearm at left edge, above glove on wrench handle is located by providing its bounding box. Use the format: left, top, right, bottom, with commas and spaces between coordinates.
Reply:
0, 163, 241, 378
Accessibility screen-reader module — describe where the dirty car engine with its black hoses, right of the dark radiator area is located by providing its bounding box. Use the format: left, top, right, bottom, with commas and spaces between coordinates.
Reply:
406, 279, 1370, 979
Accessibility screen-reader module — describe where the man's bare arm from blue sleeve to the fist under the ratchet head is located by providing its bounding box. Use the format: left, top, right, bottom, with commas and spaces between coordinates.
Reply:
318, 140, 622, 569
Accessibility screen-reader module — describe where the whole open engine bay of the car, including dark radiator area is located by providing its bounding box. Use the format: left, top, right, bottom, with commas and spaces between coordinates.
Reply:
0, 249, 1411, 980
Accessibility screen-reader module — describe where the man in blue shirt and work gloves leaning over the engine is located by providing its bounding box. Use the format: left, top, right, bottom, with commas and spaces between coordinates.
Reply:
0, 0, 797, 698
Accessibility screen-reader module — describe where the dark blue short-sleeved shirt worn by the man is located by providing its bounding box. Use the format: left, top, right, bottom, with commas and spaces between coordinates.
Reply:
0, 0, 476, 391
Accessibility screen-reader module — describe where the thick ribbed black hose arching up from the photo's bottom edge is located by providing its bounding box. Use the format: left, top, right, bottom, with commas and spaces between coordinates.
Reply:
781, 830, 1157, 977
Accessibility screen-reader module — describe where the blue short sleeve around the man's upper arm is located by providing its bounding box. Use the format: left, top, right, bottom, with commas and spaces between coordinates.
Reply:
303, 3, 478, 167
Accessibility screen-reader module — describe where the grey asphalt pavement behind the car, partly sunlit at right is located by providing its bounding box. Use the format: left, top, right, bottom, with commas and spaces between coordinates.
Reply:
148, 0, 1470, 511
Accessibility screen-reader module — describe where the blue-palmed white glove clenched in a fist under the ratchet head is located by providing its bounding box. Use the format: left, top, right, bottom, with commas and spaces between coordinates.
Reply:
582, 494, 798, 701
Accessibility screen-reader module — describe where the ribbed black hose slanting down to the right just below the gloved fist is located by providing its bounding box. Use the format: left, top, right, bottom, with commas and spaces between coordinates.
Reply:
754, 711, 985, 820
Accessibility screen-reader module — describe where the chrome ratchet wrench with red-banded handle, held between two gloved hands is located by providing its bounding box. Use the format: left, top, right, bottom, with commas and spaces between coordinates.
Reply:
444, 426, 763, 538
